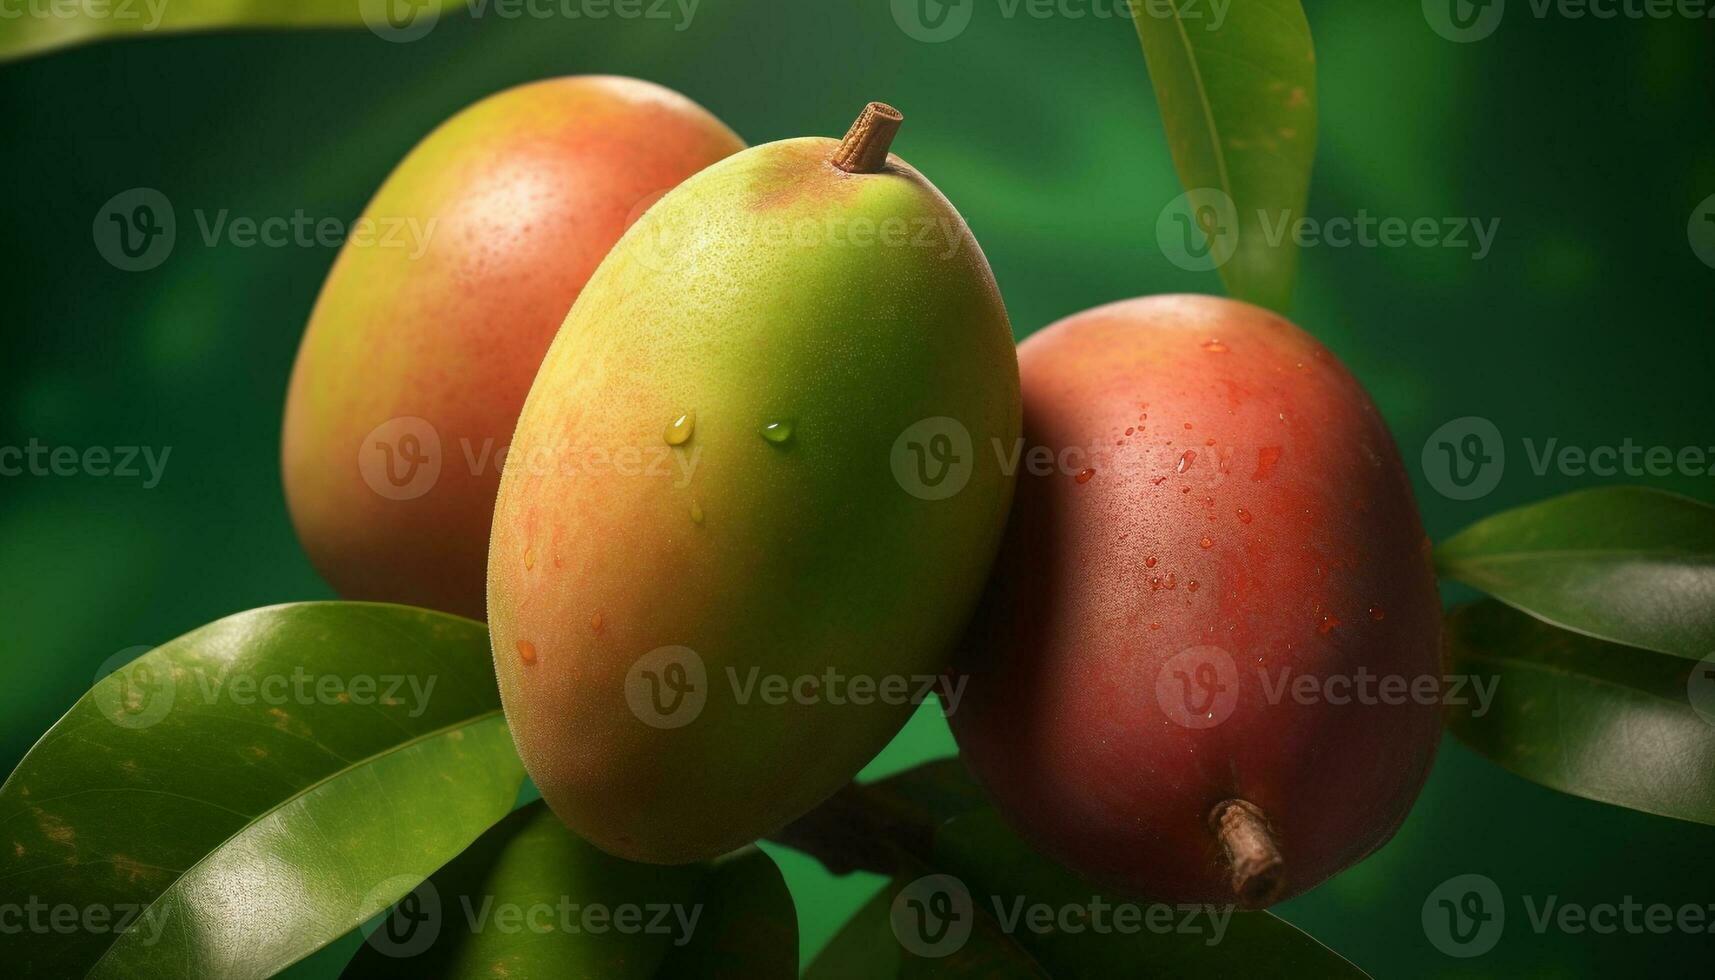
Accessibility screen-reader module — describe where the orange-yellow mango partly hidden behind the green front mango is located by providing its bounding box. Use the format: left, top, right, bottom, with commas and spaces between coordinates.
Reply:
281, 76, 744, 620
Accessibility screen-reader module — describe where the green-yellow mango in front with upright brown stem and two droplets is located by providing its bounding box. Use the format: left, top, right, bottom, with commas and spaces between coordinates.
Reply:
489, 103, 1019, 863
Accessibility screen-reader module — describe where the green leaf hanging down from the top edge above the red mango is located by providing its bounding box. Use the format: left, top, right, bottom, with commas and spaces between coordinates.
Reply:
1132, 0, 1315, 311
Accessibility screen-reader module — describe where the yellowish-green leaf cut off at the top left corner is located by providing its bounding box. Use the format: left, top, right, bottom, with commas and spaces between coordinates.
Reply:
0, 0, 463, 60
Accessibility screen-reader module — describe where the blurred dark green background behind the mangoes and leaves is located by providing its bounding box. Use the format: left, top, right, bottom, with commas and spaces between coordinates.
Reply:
0, 0, 1715, 977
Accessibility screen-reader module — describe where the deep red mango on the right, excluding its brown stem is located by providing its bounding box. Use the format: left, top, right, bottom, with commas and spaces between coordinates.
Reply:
948, 295, 1441, 904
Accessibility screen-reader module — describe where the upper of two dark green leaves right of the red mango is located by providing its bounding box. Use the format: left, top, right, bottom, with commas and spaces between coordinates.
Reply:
1435, 487, 1715, 659
